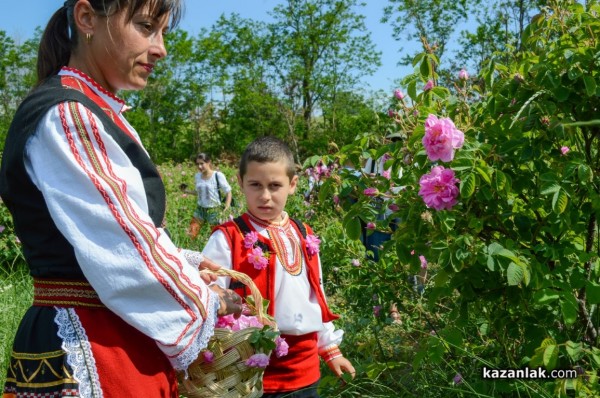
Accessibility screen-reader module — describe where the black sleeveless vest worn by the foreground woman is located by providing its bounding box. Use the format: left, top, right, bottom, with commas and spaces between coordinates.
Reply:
0, 76, 166, 279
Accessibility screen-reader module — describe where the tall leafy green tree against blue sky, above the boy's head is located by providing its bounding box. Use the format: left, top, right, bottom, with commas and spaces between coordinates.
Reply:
269, 0, 380, 139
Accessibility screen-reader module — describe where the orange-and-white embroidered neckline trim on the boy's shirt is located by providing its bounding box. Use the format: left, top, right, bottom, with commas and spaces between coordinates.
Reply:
248, 213, 302, 276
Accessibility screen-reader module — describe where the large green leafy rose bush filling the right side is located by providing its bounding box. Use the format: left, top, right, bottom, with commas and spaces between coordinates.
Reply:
319, 2, 600, 396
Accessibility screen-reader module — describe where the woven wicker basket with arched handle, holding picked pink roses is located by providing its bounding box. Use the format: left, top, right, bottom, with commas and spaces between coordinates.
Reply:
178, 269, 277, 398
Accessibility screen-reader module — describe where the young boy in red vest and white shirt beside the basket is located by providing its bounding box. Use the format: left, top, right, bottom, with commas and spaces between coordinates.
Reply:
203, 137, 355, 398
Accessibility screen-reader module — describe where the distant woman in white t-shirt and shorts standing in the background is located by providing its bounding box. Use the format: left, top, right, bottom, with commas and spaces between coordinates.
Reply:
181, 153, 232, 239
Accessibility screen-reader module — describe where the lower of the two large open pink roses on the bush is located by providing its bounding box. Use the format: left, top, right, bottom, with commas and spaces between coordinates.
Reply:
419, 166, 459, 210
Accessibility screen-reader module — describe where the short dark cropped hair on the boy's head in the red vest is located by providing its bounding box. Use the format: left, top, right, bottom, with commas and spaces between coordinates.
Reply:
240, 136, 296, 181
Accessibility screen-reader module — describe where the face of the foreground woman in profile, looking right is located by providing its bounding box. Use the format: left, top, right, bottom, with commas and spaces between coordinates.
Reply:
86, 8, 169, 93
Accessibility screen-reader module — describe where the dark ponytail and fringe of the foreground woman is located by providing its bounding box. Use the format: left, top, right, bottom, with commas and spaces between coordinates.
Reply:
37, 0, 183, 85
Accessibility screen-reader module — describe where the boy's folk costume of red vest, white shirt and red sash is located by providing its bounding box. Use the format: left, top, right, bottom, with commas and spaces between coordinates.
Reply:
202, 213, 344, 393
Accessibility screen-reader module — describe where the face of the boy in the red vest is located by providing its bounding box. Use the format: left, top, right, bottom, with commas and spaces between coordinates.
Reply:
238, 161, 298, 222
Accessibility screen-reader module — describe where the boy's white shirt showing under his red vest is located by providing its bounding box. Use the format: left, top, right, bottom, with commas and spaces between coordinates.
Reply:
202, 211, 344, 349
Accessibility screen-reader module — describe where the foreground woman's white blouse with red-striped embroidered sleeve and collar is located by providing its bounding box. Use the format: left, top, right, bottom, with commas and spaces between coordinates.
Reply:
25, 68, 219, 370
